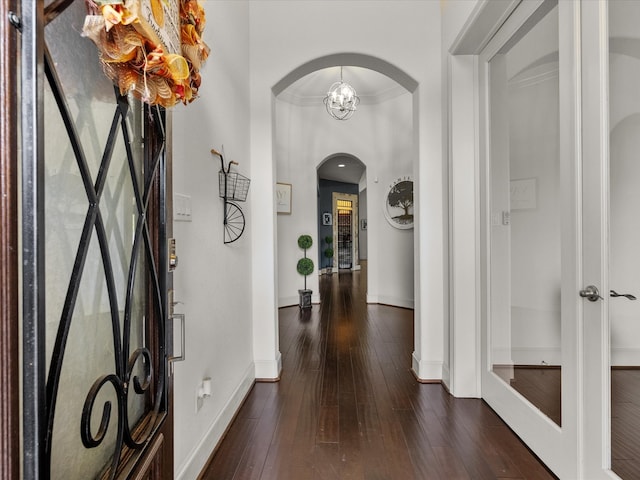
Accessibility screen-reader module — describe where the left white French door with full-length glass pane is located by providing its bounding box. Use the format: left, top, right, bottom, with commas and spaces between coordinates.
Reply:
479, 1, 583, 479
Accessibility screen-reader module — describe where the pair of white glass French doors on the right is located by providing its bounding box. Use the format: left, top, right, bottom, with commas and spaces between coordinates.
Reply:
479, 0, 640, 479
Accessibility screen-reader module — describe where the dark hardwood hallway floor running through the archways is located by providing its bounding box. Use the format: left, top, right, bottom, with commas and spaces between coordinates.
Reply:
200, 272, 555, 480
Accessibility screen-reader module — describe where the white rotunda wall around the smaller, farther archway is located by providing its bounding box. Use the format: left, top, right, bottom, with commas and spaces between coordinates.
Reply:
275, 92, 414, 308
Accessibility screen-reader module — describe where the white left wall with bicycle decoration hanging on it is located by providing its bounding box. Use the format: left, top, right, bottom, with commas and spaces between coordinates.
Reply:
173, 0, 254, 479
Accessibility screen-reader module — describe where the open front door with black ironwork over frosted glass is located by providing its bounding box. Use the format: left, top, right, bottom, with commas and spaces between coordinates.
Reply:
22, 0, 173, 480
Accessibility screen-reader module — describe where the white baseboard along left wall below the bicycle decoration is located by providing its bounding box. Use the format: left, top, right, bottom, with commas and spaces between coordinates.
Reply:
175, 365, 255, 480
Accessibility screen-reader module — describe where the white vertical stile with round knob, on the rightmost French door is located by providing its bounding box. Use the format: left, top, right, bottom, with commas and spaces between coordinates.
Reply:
580, 0, 620, 479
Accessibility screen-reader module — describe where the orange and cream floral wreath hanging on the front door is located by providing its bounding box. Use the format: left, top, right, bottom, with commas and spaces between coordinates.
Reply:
83, 0, 209, 107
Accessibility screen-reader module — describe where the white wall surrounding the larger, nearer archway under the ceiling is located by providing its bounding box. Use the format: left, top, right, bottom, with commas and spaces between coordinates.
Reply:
250, 0, 444, 379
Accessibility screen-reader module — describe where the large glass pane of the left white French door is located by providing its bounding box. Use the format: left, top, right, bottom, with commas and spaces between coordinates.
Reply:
489, 1, 562, 425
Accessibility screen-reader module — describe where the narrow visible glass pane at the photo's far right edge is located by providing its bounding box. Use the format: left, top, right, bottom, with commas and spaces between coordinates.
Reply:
608, 1, 640, 479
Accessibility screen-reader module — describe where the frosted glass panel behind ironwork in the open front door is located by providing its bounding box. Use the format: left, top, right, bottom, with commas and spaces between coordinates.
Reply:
43, 2, 171, 480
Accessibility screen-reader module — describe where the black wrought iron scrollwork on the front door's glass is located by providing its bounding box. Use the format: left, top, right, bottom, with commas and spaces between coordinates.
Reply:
44, 7, 166, 478
